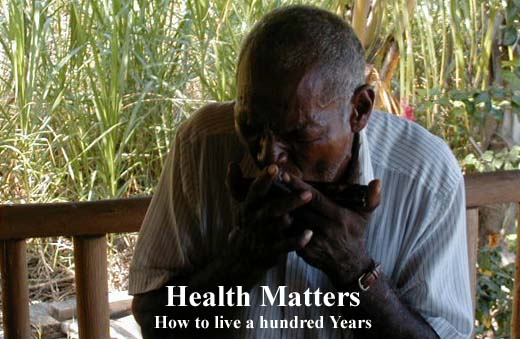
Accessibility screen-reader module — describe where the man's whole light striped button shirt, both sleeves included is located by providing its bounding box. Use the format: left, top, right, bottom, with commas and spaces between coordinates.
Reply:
129, 103, 473, 339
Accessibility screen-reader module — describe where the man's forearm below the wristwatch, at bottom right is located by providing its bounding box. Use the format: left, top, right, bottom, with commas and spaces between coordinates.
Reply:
343, 277, 439, 339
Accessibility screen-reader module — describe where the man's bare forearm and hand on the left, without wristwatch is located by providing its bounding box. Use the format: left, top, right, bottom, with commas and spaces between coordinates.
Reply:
133, 164, 312, 339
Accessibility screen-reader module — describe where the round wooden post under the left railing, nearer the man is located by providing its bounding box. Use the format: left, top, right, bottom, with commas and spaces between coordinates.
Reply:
74, 235, 110, 339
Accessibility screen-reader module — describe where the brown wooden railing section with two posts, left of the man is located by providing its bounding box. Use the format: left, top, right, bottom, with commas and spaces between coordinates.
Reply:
0, 198, 150, 339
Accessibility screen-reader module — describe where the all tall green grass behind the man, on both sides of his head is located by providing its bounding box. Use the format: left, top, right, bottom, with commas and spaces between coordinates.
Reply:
0, 0, 515, 202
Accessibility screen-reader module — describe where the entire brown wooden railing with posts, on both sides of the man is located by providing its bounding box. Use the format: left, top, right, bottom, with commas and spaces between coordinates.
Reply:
0, 171, 520, 339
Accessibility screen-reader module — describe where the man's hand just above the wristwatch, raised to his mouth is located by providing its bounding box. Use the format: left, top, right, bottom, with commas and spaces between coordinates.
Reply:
284, 174, 381, 287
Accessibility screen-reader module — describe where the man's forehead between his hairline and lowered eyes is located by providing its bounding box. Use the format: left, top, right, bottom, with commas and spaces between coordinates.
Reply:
235, 58, 346, 128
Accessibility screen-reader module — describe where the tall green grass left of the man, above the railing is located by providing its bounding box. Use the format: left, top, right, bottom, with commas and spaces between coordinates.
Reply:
0, 0, 337, 202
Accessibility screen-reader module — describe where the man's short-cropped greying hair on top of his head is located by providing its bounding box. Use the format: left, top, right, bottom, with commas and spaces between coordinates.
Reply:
239, 6, 365, 100
